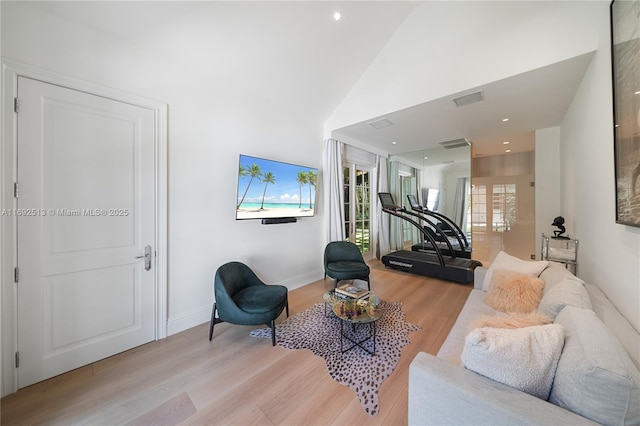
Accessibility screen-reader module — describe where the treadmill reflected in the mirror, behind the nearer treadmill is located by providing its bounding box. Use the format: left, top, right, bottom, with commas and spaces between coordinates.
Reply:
407, 195, 471, 259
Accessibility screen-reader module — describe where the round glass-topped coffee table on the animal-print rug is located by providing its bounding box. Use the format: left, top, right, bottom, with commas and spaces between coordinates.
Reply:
322, 290, 382, 355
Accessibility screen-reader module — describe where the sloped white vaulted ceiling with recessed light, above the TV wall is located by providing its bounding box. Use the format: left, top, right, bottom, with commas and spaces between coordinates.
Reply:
22, 0, 420, 122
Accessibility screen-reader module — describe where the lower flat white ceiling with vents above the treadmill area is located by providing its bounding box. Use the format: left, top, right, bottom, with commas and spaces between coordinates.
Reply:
333, 54, 592, 159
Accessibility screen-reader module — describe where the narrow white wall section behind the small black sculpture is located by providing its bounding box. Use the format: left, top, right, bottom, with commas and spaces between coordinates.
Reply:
535, 127, 572, 260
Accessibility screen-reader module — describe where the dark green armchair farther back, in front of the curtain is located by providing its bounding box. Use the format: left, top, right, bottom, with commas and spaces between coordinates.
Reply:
324, 241, 371, 290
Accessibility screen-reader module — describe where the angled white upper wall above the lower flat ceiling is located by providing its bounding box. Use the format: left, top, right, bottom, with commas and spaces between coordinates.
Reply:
325, 1, 598, 131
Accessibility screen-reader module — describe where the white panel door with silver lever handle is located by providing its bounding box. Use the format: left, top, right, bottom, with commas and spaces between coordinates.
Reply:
16, 77, 156, 388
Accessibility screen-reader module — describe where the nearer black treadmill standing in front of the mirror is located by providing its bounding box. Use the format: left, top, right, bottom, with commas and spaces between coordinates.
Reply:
378, 192, 482, 283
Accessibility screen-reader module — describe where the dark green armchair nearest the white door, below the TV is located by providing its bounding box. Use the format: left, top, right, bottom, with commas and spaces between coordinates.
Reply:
209, 262, 289, 346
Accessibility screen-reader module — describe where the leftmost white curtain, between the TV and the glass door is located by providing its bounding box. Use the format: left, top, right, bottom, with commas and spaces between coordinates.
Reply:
322, 139, 345, 244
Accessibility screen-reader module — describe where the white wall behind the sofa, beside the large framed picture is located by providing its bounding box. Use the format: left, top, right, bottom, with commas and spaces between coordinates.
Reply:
560, 2, 640, 330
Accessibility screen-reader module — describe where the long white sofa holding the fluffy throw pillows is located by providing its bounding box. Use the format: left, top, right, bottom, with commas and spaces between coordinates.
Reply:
408, 262, 640, 425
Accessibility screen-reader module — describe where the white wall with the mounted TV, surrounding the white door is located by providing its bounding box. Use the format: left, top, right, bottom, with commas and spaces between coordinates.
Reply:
1, 2, 324, 338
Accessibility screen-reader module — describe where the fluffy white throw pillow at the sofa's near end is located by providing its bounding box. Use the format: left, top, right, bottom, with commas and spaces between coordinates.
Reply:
461, 324, 564, 400
